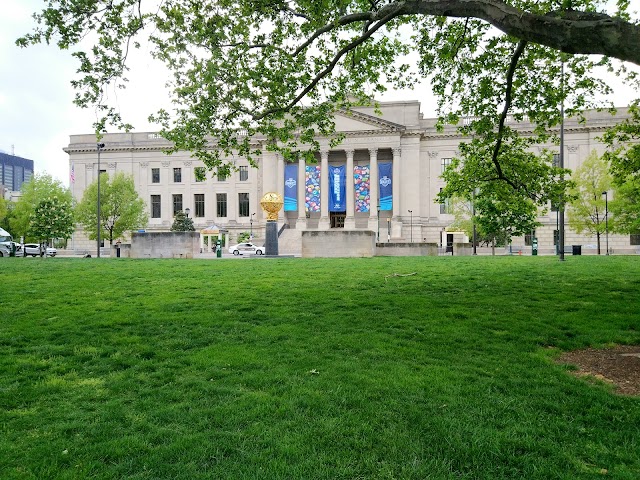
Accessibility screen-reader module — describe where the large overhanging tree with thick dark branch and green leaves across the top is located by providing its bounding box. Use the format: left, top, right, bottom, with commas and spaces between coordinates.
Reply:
18, 0, 640, 213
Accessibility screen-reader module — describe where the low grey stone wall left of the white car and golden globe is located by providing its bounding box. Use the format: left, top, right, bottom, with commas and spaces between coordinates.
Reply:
131, 232, 200, 258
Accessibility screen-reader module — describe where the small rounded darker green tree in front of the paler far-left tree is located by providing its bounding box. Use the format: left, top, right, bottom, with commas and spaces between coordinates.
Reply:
28, 195, 74, 249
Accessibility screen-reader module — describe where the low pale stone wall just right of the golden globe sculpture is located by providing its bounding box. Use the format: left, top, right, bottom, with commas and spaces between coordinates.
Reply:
302, 230, 376, 258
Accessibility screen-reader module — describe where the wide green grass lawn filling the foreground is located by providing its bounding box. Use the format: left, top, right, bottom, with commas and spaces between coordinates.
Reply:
0, 257, 640, 480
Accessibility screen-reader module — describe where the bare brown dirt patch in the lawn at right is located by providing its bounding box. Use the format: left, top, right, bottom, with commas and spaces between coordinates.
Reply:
557, 345, 640, 396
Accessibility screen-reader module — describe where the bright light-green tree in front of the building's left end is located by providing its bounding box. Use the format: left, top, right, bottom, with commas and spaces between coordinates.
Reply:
75, 173, 147, 245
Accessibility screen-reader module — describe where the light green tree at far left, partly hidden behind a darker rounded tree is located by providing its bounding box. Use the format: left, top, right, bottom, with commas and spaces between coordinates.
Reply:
9, 173, 73, 241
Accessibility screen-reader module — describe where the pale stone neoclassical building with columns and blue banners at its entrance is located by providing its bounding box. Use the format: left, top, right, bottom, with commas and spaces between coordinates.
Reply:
65, 101, 640, 253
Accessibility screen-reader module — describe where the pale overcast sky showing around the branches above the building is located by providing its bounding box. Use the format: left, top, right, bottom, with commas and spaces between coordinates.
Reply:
0, 0, 638, 185
